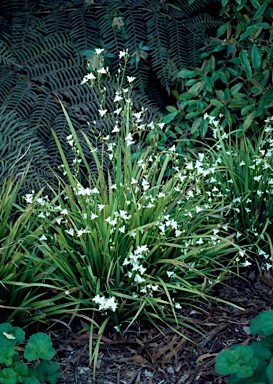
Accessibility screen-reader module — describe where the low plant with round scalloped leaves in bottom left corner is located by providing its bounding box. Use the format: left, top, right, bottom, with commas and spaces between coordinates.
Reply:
0, 323, 60, 384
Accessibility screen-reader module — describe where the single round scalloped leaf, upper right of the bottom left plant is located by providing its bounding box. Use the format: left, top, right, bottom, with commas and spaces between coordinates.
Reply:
24, 332, 55, 361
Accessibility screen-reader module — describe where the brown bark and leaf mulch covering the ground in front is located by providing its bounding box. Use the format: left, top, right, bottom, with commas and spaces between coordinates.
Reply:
51, 274, 273, 384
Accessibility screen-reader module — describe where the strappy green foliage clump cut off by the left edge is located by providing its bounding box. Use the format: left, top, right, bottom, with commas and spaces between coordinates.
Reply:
0, 175, 53, 321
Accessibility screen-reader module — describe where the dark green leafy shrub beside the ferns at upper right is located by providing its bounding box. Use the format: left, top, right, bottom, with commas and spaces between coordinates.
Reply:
165, 0, 273, 138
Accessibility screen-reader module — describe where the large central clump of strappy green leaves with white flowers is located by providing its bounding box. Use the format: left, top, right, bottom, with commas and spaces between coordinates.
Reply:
19, 52, 238, 374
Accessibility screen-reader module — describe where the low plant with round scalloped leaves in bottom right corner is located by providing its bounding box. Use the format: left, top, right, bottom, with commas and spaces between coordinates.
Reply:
215, 311, 273, 384
